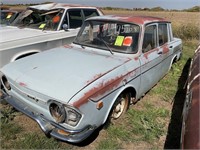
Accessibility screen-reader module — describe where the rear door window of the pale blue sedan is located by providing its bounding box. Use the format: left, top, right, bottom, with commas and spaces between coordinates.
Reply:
158, 24, 168, 46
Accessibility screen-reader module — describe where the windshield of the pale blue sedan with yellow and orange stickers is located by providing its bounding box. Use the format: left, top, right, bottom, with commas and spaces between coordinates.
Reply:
74, 20, 140, 53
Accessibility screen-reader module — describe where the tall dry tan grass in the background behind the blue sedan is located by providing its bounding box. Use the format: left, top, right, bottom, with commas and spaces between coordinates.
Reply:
103, 9, 200, 40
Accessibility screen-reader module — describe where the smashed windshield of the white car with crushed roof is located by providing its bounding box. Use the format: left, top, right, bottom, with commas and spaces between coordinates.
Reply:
12, 9, 64, 31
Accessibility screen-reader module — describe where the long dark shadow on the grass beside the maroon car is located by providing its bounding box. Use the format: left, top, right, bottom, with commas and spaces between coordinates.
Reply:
164, 58, 191, 149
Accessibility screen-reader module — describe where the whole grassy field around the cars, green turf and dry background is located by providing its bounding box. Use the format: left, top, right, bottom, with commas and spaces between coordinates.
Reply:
0, 10, 200, 150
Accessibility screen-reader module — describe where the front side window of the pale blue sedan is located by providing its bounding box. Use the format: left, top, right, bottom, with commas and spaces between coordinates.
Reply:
142, 25, 157, 53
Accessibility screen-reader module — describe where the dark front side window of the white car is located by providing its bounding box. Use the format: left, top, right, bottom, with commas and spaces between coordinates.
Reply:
68, 9, 83, 29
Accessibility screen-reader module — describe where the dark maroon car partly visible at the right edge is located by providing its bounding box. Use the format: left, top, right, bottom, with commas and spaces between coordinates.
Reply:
181, 46, 200, 149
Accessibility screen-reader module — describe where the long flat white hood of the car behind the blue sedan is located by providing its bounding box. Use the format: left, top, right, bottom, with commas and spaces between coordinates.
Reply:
0, 26, 79, 51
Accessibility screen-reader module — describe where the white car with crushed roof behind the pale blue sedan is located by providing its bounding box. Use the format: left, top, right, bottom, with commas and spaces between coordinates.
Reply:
0, 3, 103, 68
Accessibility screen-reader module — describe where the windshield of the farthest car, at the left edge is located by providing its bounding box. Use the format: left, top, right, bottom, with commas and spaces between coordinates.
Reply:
0, 10, 18, 25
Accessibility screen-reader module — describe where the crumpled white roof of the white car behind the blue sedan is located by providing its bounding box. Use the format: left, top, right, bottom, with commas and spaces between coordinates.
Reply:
29, 3, 99, 10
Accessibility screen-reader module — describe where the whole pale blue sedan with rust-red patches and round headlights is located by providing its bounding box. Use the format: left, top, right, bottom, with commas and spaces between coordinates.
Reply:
1, 16, 182, 143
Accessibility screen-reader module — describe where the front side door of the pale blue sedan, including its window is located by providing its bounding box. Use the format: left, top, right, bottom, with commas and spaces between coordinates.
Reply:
140, 23, 162, 94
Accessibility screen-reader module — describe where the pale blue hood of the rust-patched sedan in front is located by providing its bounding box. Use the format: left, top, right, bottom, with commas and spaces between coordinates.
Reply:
2, 47, 128, 103
